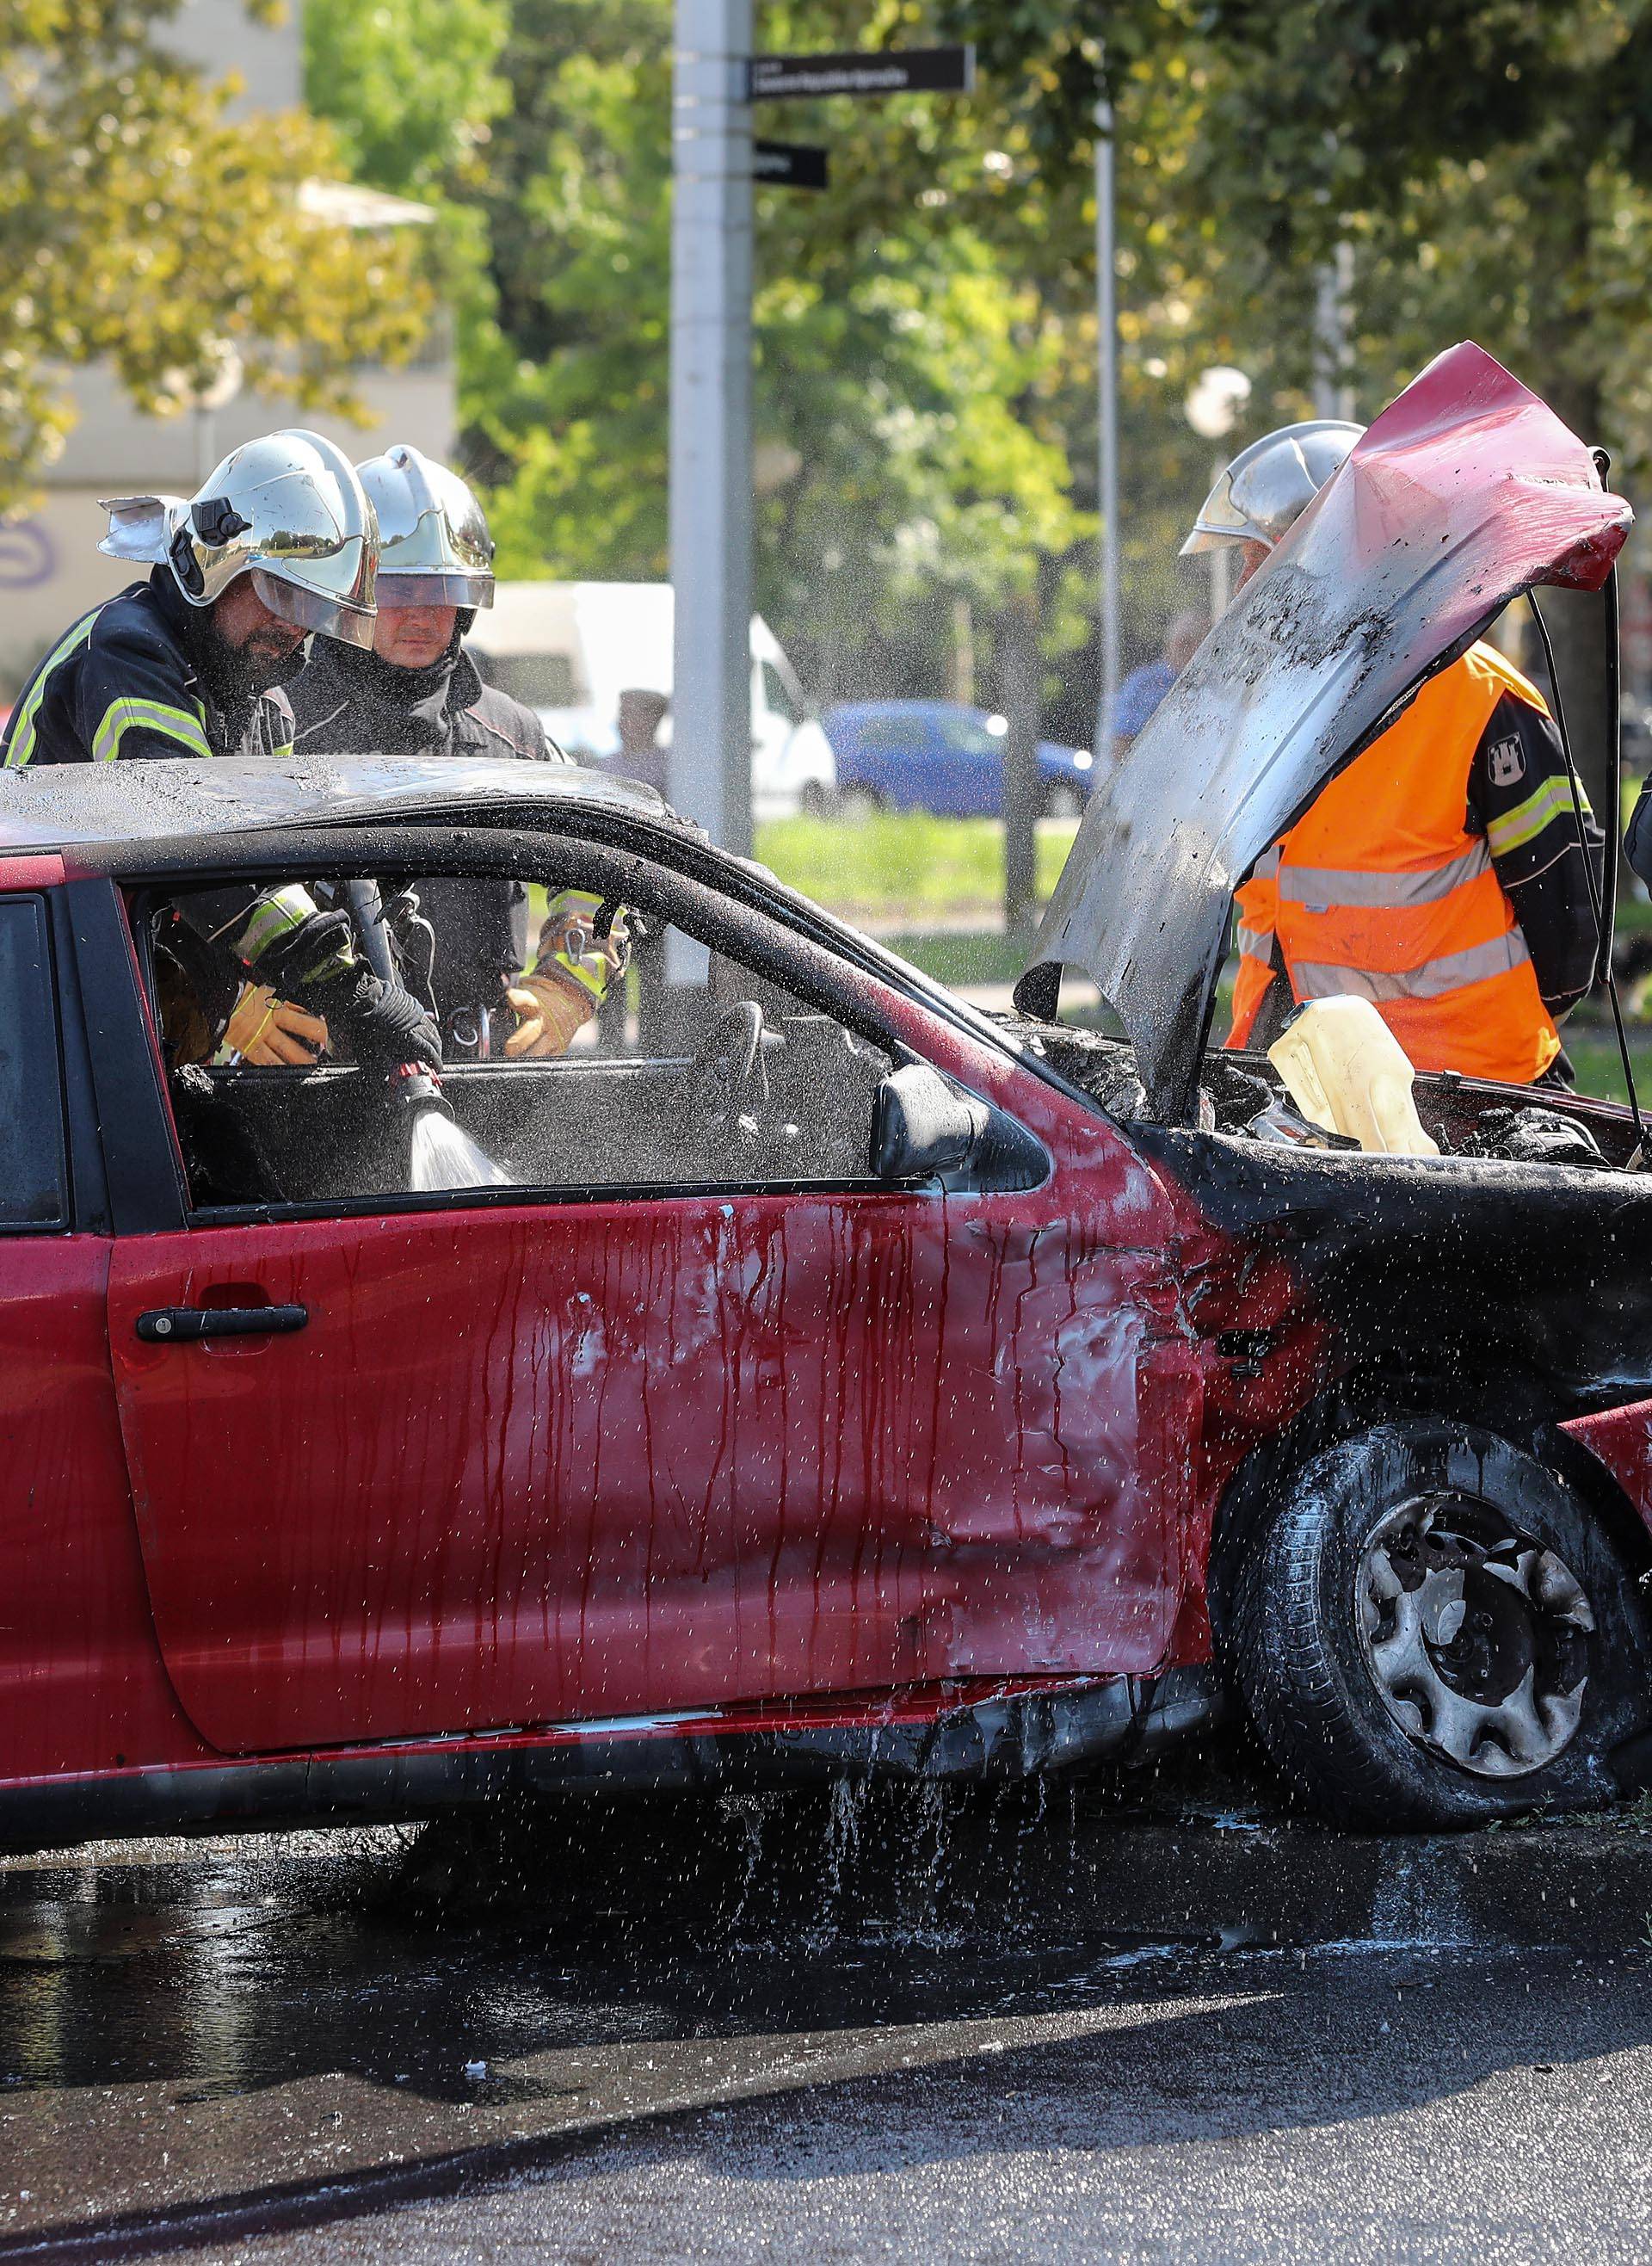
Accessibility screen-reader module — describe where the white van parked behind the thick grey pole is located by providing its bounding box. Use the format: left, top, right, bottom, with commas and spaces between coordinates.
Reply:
467, 583, 836, 818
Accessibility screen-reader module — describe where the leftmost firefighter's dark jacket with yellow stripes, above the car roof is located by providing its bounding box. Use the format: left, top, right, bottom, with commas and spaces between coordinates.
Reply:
0, 566, 293, 770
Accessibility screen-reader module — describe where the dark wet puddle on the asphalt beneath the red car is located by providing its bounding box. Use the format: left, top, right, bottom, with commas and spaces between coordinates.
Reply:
0, 1787, 1214, 2108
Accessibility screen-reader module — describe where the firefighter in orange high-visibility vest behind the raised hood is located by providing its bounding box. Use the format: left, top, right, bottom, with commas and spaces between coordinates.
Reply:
1183, 419, 1602, 1085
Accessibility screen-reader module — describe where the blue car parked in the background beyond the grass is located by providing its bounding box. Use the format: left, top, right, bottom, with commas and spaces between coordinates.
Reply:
820, 701, 1094, 818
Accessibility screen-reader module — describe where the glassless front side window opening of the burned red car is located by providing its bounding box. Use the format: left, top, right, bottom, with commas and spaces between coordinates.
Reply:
136, 874, 893, 1206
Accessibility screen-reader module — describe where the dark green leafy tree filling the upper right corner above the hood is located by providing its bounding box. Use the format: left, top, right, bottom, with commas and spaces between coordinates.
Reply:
952, 0, 1652, 811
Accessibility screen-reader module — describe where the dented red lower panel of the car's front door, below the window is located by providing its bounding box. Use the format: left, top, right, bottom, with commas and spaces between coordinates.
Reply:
108, 1158, 1190, 1751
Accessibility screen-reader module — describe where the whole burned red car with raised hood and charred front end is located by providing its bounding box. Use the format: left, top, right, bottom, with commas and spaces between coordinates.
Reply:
0, 349, 1652, 1844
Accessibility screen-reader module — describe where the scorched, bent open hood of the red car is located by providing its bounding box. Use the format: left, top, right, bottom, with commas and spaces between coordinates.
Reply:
1018, 344, 1631, 1121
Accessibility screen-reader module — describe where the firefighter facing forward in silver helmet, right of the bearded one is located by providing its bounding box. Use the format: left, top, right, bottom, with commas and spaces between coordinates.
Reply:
293, 444, 626, 1056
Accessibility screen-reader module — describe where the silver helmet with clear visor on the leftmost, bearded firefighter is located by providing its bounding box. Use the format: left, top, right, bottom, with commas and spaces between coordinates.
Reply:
154, 430, 379, 645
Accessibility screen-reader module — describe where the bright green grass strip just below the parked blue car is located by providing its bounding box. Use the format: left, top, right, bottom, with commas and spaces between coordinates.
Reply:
755, 812, 1076, 934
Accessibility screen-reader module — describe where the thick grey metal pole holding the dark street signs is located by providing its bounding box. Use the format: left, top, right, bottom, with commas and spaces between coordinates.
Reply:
666, 0, 752, 855
